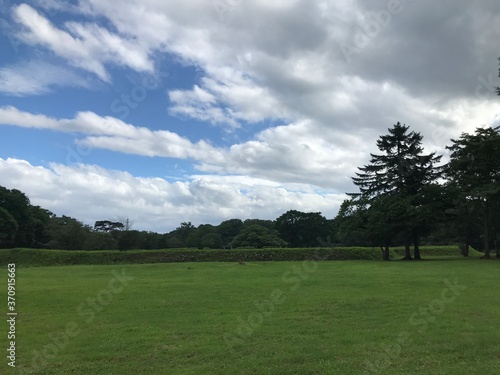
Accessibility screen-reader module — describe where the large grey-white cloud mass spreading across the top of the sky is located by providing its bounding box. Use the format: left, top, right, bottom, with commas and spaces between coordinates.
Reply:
9, 0, 500, 132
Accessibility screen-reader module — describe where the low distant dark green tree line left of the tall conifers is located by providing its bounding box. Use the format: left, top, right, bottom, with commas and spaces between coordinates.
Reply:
0, 191, 333, 250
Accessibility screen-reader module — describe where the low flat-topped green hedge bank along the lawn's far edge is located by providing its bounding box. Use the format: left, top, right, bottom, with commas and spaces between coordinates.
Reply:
0, 246, 481, 267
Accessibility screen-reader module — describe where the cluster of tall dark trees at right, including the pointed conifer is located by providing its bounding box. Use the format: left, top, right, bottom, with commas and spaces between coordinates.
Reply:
336, 123, 500, 260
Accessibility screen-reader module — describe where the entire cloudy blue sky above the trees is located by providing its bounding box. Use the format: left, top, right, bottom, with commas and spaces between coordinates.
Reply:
0, 0, 500, 233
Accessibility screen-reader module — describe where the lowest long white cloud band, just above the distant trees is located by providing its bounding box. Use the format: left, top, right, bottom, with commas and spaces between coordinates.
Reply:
0, 158, 344, 232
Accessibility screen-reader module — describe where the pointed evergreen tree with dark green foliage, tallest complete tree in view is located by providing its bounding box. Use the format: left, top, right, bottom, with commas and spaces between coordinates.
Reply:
346, 122, 442, 260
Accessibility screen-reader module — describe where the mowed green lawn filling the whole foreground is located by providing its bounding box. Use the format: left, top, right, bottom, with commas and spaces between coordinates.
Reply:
0, 258, 500, 375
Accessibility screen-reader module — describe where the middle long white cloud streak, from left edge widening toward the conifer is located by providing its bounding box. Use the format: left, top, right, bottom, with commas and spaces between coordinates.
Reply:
0, 107, 366, 192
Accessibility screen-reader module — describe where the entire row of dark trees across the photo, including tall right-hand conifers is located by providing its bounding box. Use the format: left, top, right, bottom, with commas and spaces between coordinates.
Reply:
0, 123, 500, 259
